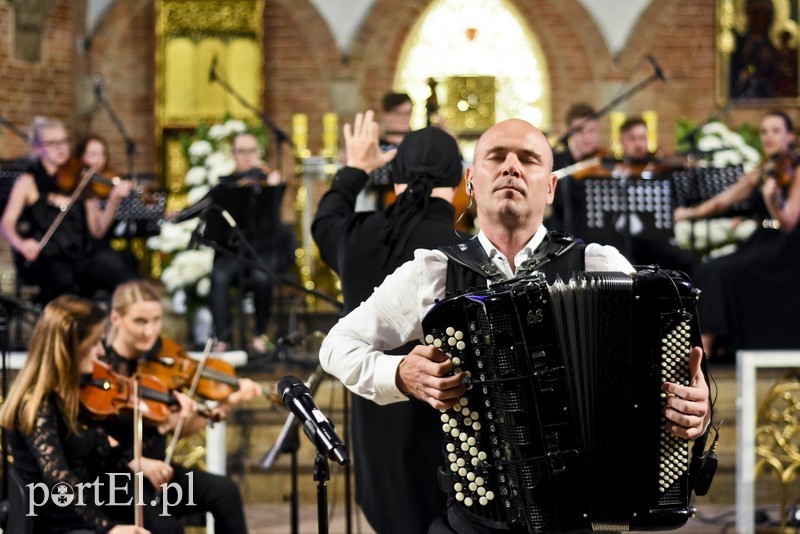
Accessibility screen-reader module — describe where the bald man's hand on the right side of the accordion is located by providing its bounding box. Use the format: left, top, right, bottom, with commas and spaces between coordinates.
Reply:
661, 347, 711, 439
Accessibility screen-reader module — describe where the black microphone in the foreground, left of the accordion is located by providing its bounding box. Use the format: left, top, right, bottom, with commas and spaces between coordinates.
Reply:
278, 375, 350, 465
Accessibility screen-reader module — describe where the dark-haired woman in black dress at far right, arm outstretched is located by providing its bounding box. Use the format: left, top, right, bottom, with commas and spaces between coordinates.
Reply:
675, 110, 800, 354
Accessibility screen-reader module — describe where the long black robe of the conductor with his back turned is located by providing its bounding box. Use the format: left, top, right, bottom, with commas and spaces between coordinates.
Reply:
312, 167, 469, 534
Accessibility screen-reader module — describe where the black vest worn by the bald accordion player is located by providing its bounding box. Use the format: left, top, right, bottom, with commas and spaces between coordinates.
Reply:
439, 231, 586, 295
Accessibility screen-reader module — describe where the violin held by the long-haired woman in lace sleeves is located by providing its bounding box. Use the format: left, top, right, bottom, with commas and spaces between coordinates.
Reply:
80, 362, 219, 424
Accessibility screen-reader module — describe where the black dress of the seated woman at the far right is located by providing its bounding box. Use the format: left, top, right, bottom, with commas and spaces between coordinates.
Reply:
695, 182, 800, 350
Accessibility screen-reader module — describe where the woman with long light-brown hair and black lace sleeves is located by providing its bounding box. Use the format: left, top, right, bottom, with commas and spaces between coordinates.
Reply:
0, 295, 148, 534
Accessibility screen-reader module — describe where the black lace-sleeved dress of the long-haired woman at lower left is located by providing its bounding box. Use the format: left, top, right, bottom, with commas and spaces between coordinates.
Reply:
7, 394, 119, 533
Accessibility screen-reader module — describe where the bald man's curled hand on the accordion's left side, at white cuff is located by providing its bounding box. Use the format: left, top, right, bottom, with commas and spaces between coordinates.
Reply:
396, 345, 467, 410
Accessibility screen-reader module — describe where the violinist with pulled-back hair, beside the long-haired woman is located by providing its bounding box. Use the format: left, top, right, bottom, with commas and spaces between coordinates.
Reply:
101, 280, 261, 533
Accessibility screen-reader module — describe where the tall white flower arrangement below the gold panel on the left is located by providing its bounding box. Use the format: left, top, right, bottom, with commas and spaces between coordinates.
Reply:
147, 119, 263, 313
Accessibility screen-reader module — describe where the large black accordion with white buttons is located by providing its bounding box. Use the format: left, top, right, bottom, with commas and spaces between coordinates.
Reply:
422, 269, 700, 532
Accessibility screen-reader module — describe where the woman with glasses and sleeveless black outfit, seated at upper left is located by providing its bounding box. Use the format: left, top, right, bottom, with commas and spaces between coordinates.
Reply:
0, 117, 135, 301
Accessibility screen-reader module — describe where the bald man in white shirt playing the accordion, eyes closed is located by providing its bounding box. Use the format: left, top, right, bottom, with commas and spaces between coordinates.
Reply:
320, 119, 710, 533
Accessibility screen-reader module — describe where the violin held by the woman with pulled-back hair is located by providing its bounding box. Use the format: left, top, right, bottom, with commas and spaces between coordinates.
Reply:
138, 337, 271, 401
